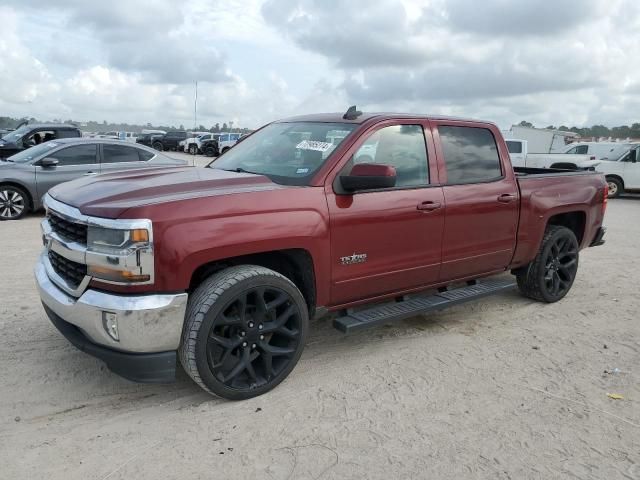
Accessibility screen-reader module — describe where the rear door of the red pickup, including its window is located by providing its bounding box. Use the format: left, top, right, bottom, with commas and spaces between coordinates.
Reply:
433, 121, 520, 281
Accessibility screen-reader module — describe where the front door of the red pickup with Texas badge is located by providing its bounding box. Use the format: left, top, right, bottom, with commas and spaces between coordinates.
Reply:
325, 120, 445, 305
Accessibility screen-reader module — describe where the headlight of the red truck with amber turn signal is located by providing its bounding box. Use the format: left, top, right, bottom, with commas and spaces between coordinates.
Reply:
87, 220, 154, 285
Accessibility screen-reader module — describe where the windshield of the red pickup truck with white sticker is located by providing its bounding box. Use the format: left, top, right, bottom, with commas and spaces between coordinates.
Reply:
208, 122, 356, 185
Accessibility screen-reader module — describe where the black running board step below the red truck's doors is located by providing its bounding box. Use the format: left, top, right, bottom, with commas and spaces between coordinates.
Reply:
333, 279, 516, 333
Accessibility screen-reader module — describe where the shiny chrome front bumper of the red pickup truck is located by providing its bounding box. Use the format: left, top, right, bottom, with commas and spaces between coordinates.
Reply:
35, 253, 187, 353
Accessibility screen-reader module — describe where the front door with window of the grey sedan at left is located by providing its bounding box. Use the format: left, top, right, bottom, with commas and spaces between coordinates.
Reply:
34, 143, 100, 197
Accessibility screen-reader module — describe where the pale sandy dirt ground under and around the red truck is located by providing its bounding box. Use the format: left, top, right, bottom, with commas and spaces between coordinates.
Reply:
0, 198, 640, 480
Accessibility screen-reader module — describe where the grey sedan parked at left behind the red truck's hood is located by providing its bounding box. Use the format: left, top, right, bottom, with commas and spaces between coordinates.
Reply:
0, 138, 187, 220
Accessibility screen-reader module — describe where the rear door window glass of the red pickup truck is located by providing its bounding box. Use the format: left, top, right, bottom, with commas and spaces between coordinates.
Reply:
438, 126, 502, 185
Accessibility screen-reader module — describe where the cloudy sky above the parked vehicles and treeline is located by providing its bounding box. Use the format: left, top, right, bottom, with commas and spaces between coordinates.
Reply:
0, 0, 640, 127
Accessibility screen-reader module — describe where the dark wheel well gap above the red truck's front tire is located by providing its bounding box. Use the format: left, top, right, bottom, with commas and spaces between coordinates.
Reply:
189, 248, 316, 318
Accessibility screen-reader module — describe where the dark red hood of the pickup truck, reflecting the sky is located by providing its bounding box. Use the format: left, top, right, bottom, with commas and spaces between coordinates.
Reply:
49, 167, 286, 218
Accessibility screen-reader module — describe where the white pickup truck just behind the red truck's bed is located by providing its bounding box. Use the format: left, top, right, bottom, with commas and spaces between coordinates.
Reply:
505, 138, 600, 170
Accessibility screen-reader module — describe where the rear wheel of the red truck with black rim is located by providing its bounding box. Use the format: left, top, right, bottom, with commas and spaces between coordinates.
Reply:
516, 225, 579, 303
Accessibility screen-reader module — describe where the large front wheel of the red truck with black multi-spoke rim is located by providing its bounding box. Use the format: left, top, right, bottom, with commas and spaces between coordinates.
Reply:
179, 265, 309, 400
